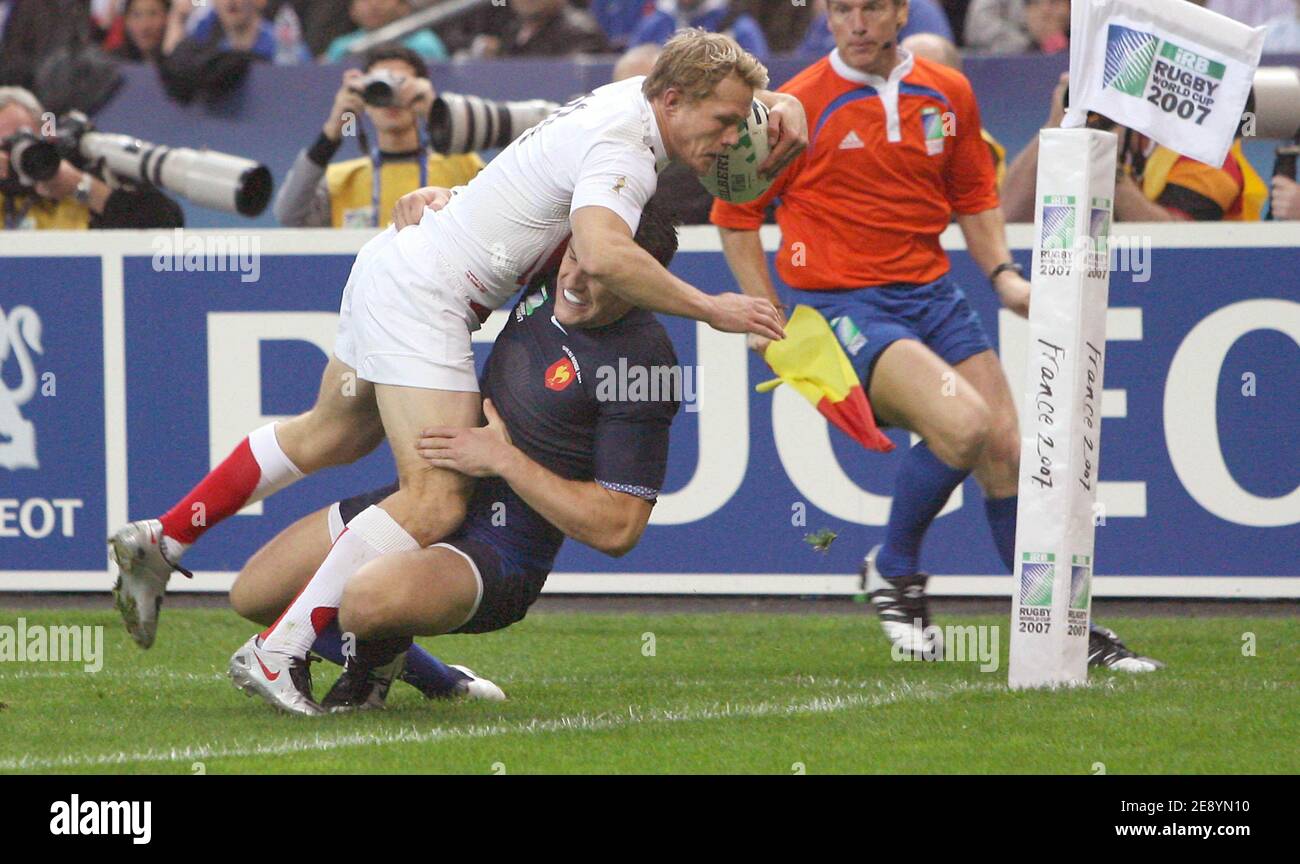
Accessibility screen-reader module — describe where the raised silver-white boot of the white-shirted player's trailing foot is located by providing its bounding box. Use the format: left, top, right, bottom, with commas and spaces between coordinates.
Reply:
108, 518, 192, 648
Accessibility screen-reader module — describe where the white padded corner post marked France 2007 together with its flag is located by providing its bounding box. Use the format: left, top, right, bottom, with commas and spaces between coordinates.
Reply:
1009, 0, 1265, 687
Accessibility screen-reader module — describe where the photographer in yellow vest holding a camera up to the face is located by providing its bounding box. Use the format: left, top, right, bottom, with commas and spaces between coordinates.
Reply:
276, 43, 484, 227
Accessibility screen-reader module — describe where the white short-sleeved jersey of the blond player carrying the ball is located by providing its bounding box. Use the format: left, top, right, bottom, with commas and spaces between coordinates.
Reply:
420, 77, 668, 309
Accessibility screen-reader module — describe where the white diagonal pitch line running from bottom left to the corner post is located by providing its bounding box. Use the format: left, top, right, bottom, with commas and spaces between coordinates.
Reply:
0, 682, 1005, 770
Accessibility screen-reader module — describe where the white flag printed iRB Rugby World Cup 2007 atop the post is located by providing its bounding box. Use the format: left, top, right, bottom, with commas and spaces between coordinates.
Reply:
1063, 0, 1265, 165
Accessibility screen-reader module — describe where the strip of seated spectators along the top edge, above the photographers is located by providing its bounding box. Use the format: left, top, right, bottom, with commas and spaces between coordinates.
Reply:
0, 0, 1300, 69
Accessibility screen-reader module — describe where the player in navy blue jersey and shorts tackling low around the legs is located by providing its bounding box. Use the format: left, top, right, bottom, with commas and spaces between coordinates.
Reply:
230, 198, 681, 713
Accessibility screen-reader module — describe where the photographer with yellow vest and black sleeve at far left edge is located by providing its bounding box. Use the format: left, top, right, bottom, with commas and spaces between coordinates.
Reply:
0, 87, 185, 230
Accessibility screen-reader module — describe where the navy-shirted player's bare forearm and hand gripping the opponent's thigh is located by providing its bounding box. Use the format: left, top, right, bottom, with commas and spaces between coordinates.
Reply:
416, 399, 651, 557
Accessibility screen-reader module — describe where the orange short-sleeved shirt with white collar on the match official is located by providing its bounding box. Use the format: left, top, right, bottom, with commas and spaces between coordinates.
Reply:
710, 51, 998, 290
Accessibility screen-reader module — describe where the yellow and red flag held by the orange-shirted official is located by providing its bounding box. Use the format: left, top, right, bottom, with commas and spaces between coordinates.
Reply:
757, 305, 894, 453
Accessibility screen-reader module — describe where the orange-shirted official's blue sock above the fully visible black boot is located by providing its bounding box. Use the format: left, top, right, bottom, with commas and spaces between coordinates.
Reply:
876, 442, 970, 579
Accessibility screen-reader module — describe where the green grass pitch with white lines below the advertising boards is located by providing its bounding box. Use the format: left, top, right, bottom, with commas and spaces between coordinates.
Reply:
0, 609, 1300, 774
